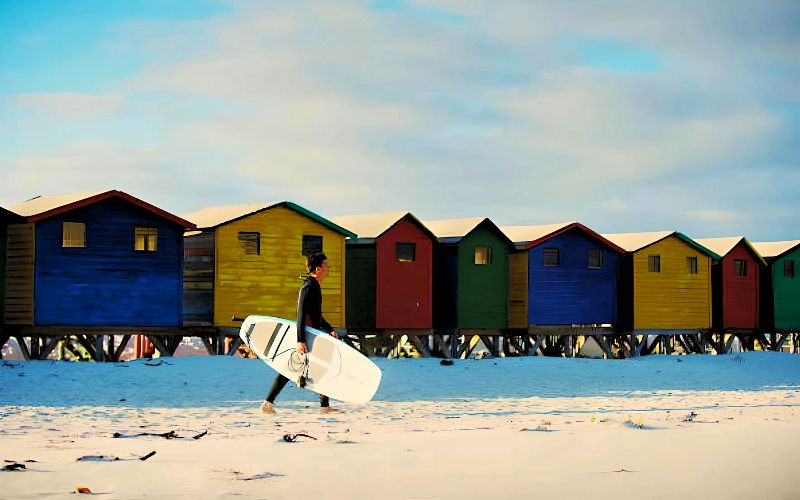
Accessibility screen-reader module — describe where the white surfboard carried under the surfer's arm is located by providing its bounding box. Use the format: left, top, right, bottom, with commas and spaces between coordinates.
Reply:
239, 316, 381, 403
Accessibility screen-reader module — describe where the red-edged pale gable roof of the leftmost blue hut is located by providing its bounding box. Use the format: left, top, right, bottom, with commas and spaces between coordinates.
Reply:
12, 189, 195, 229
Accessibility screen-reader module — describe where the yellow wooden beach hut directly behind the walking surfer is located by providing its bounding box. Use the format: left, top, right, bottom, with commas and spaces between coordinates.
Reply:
184, 201, 356, 327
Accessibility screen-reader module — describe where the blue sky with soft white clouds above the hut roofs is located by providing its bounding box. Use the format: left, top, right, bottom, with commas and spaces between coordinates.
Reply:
0, 0, 800, 241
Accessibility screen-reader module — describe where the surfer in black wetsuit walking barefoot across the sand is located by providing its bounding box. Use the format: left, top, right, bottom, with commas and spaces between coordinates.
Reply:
261, 253, 339, 413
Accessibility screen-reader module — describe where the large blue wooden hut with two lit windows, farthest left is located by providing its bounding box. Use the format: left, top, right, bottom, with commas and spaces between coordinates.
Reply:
5, 190, 195, 327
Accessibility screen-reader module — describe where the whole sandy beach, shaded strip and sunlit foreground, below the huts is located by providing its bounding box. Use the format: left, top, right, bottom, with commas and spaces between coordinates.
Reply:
0, 352, 800, 499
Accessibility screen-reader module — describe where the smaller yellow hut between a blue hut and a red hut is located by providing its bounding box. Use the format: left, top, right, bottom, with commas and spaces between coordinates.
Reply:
602, 231, 720, 354
